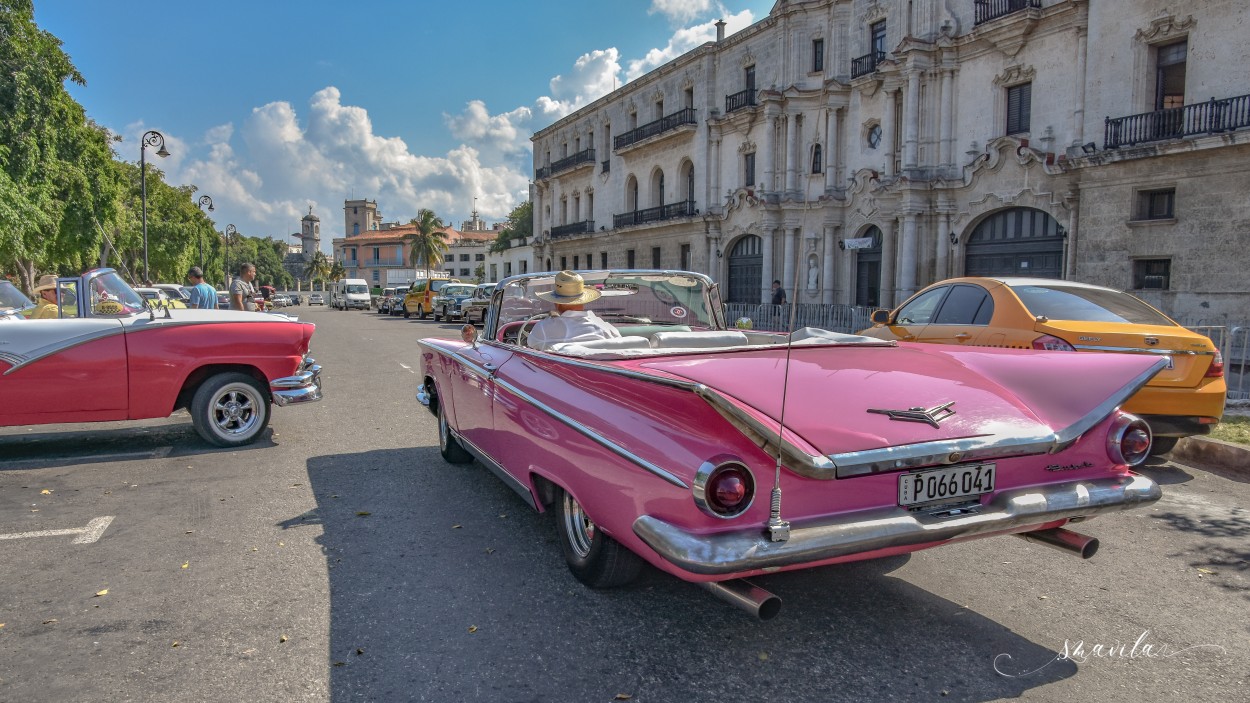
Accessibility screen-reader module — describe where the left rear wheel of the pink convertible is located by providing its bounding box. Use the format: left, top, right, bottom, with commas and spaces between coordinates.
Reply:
555, 488, 643, 588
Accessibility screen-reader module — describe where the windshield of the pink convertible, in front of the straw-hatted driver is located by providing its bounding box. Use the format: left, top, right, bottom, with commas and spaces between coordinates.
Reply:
499, 271, 718, 329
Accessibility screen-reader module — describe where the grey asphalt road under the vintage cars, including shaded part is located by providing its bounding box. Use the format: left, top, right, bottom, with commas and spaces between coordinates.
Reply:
0, 305, 1250, 703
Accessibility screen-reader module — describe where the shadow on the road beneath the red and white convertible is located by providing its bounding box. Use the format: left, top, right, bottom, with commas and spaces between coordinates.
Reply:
0, 415, 276, 470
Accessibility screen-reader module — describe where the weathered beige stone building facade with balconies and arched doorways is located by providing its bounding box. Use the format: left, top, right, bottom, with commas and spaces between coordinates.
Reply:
533, 0, 1250, 323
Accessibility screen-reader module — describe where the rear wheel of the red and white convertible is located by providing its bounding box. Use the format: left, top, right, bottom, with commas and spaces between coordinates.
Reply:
191, 373, 270, 447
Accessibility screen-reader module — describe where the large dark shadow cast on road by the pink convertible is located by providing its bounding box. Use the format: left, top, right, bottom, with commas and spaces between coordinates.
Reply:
290, 447, 1076, 702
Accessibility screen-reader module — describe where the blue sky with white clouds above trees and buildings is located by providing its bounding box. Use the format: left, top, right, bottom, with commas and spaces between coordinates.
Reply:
35, 0, 773, 250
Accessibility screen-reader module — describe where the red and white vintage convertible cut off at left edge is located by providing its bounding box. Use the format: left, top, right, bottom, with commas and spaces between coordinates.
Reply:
0, 269, 321, 447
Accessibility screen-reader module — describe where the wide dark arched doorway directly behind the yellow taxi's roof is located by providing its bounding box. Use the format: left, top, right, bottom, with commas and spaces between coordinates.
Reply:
964, 208, 1064, 278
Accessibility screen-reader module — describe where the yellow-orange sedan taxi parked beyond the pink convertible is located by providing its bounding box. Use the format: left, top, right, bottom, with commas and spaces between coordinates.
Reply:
860, 278, 1228, 454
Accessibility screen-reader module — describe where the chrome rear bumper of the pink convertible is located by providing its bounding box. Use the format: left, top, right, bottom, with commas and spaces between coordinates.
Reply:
634, 474, 1163, 575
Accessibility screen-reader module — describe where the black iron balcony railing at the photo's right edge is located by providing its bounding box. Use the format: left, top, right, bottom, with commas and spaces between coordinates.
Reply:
1103, 95, 1250, 149
